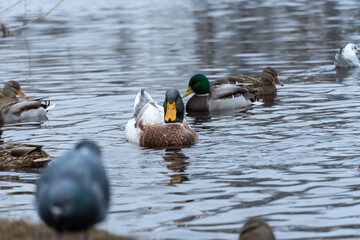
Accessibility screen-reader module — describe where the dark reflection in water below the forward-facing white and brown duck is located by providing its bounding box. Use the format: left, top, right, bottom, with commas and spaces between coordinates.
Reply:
163, 149, 189, 186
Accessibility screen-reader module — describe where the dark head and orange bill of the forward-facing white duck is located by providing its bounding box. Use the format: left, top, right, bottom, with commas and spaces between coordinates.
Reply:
164, 89, 184, 123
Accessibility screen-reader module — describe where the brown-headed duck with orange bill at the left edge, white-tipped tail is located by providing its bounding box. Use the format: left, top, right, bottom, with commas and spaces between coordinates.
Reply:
0, 81, 55, 124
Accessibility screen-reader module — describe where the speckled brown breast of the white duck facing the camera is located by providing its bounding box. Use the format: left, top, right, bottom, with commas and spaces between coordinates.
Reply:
139, 120, 199, 147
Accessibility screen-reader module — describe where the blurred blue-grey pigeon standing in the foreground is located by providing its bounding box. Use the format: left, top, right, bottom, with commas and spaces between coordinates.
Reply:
36, 140, 110, 239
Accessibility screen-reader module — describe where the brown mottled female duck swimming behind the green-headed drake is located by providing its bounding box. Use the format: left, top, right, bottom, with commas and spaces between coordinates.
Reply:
226, 67, 284, 99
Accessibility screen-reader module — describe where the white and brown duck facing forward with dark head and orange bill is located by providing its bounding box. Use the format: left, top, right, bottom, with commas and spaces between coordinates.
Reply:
125, 89, 198, 148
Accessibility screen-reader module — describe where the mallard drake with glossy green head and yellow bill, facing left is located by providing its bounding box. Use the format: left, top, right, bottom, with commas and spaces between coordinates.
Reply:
182, 74, 255, 113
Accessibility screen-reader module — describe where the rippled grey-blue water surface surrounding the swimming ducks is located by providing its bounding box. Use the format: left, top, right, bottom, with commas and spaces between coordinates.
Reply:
0, 0, 360, 239
